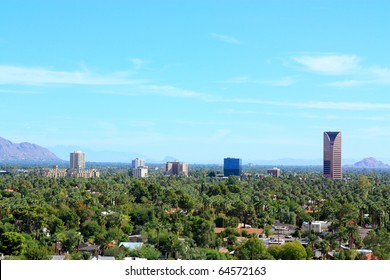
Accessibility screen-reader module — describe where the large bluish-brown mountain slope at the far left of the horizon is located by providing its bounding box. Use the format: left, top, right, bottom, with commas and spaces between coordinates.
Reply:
0, 137, 62, 162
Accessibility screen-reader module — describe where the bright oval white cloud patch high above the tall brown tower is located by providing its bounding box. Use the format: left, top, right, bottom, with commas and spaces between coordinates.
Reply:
293, 55, 360, 75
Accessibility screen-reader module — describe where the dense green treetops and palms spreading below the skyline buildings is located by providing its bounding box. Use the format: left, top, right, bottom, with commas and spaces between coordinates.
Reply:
0, 166, 390, 259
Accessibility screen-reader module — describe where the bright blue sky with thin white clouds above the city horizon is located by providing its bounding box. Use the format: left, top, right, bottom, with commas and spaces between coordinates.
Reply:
0, 0, 390, 163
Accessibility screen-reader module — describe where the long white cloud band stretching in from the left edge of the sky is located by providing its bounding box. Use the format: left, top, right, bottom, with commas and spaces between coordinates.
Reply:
0, 65, 144, 85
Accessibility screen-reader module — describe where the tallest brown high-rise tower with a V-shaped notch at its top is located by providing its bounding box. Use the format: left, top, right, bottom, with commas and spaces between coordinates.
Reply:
324, 131, 343, 180
